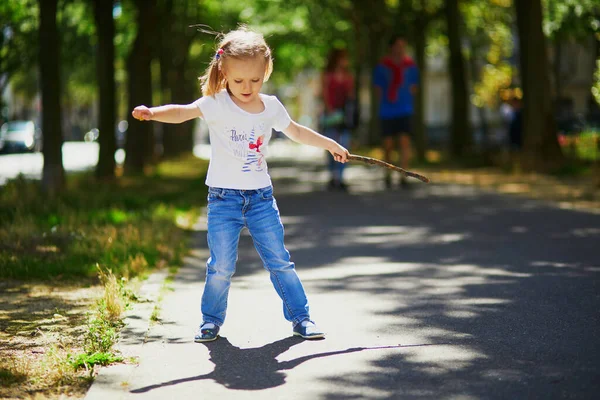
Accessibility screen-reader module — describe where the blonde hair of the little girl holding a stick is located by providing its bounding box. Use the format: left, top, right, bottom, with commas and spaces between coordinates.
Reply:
199, 26, 273, 96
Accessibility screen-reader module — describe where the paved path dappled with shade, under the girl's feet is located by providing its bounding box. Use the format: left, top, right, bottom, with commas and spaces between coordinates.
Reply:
87, 152, 600, 400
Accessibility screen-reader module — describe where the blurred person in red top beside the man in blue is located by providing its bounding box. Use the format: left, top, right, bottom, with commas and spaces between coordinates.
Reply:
321, 49, 354, 191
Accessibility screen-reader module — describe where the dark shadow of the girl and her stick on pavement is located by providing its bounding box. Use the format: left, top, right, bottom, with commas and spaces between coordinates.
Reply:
131, 337, 386, 393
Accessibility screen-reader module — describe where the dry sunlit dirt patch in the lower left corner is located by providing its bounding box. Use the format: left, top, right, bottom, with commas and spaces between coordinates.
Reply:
0, 281, 102, 399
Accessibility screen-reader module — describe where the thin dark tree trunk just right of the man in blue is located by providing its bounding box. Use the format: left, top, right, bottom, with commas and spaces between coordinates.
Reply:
414, 18, 427, 161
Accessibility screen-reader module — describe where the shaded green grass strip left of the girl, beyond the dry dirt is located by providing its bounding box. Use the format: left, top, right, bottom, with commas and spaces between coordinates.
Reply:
0, 157, 207, 280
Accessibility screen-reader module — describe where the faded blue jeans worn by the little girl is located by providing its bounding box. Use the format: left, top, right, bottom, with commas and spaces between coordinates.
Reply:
202, 187, 309, 326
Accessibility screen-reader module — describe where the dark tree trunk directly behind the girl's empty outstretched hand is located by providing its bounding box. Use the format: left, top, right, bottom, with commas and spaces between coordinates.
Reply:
125, 0, 156, 175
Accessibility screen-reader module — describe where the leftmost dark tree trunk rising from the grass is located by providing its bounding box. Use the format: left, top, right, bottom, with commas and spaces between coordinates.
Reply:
38, 0, 65, 195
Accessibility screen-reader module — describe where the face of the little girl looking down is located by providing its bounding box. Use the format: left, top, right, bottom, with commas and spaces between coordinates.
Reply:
223, 57, 267, 104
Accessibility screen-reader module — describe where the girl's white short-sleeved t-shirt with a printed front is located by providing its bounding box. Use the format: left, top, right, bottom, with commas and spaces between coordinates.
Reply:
194, 90, 291, 190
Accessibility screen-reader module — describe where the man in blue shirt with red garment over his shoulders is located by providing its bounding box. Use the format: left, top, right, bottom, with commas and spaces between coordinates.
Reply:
373, 36, 419, 188
